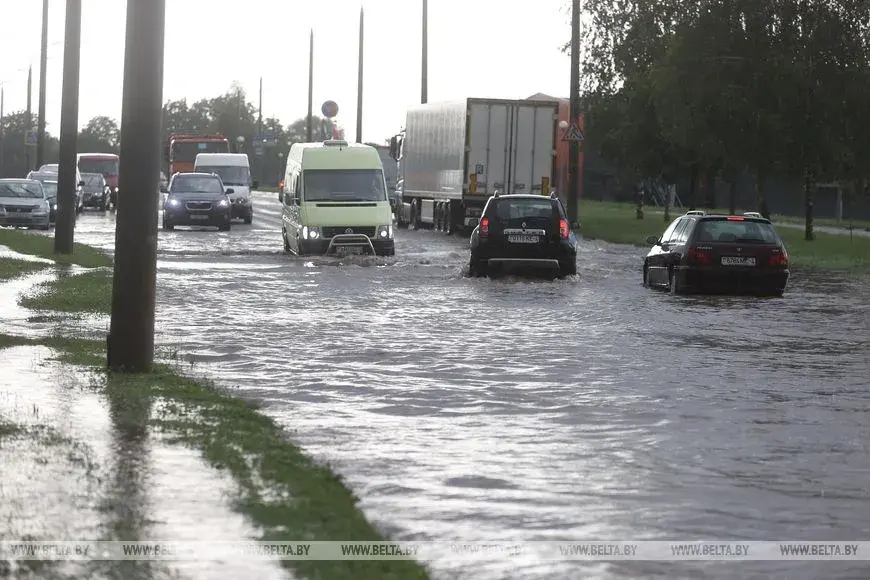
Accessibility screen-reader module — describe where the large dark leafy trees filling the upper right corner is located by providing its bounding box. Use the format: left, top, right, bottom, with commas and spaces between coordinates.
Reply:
566, 0, 870, 239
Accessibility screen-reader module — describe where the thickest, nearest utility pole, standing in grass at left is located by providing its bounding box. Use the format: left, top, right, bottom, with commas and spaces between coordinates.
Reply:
106, 0, 166, 373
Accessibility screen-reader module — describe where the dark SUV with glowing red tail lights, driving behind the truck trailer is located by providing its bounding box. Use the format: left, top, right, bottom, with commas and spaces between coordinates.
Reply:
469, 194, 577, 277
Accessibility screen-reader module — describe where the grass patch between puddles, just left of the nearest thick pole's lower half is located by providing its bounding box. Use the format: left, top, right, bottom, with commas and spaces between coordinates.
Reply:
20, 270, 112, 314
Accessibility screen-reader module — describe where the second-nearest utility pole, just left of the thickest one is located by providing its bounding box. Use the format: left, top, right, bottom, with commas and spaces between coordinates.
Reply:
54, 0, 82, 254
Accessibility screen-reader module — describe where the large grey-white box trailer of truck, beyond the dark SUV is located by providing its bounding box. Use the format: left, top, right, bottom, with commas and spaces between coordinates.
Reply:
390, 98, 559, 233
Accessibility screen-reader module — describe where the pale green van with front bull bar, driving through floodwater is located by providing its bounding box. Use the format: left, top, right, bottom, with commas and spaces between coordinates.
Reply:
278, 140, 396, 256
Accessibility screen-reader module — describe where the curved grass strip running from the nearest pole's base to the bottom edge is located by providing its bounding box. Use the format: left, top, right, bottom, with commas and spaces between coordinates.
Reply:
0, 334, 428, 580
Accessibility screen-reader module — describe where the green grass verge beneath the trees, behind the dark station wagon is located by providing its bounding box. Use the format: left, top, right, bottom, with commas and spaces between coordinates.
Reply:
580, 200, 870, 272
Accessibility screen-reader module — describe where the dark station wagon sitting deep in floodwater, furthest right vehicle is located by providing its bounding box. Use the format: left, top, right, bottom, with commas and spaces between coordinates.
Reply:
643, 211, 789, 296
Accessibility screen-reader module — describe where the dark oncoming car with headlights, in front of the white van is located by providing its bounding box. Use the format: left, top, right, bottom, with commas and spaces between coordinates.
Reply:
163, 173, 233, 232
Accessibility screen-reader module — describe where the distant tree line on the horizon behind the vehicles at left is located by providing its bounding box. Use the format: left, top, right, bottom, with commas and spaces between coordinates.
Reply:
0, 83, 344, 184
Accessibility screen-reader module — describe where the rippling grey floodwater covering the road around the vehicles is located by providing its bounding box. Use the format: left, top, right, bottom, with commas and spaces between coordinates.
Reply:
61, 194, 870, 580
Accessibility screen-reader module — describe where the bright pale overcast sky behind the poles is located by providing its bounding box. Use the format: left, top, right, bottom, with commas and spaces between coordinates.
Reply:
0, 0, 570, 142
